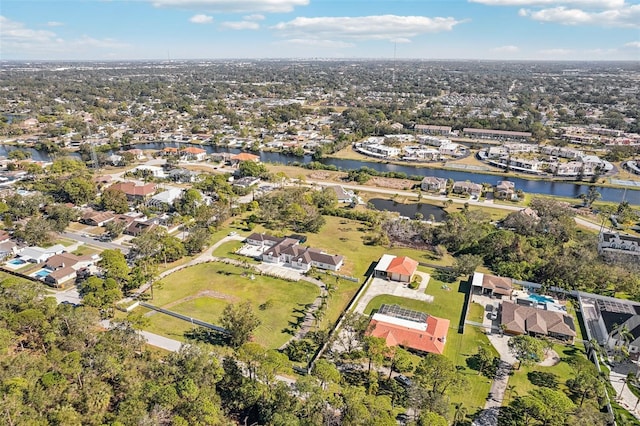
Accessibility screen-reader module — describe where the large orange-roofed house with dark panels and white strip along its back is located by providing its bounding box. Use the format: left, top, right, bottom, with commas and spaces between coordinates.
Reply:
366, 305, 450, 355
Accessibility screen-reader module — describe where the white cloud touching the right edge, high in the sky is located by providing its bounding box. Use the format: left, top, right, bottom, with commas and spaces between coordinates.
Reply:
519, 4, 640, 28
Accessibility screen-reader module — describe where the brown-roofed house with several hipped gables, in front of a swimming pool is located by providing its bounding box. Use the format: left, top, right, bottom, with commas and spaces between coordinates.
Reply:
500, 299, 576, 343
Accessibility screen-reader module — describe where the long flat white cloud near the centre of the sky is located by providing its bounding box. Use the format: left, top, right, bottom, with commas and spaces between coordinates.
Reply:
272, 15, 463, 40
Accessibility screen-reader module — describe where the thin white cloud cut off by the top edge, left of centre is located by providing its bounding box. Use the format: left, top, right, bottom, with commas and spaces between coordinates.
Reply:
148, 0, 309, 13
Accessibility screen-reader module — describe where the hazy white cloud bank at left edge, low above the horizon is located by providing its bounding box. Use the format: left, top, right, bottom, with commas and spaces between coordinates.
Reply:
0, 16, 129, 59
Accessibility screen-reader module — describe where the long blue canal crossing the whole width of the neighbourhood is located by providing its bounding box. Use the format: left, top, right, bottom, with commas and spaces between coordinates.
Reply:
0, 142, 640, 205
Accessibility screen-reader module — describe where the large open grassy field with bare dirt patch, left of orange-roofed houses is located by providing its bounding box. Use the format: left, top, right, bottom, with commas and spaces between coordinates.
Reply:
144, 263, 320, 348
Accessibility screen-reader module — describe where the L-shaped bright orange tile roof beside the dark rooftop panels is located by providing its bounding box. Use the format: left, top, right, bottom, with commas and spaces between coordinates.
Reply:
367, 315, 450, 355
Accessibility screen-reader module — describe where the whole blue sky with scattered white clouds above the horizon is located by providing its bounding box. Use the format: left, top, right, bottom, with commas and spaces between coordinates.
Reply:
0, 0, 640, 60
